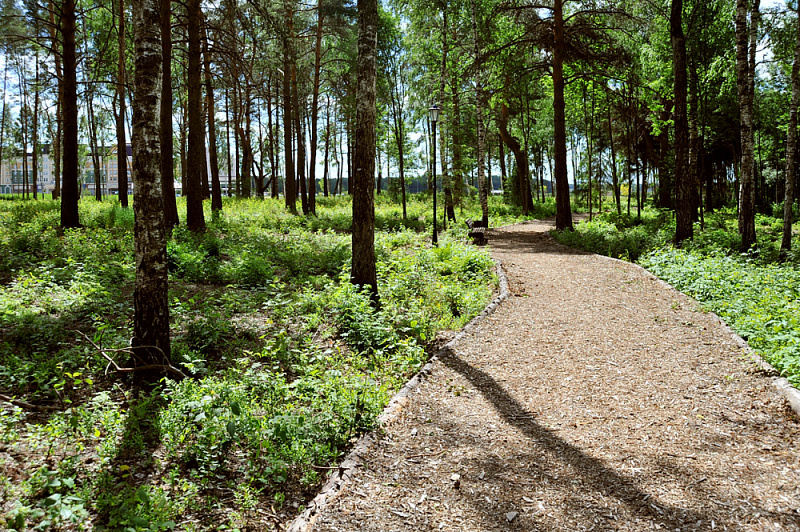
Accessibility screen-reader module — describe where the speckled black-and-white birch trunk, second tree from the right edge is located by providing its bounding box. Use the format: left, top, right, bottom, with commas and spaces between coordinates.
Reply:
736, 0, 759, 252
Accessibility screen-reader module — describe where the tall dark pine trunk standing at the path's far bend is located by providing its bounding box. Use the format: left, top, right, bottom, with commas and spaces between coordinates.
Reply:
553, 0, 572, 231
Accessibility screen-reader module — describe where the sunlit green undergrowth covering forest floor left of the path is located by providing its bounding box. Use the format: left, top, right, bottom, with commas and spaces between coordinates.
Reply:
0, 198, 520, 531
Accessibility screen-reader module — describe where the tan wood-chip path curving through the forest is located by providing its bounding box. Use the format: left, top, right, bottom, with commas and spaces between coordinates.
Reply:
312, 221, 800, 532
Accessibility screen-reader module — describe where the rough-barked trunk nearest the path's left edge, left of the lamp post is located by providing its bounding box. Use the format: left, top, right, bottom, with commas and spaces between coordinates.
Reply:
349, 0, 379, 305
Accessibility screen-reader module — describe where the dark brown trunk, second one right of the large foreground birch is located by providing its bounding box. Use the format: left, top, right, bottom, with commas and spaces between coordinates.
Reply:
186, 0, 206, 233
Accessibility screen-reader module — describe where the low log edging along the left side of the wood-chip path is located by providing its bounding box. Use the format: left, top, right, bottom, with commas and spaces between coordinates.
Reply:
287, 259, 511, 532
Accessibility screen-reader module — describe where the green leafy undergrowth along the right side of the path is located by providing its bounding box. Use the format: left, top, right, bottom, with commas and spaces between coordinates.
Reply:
553, 206, 800, 387
